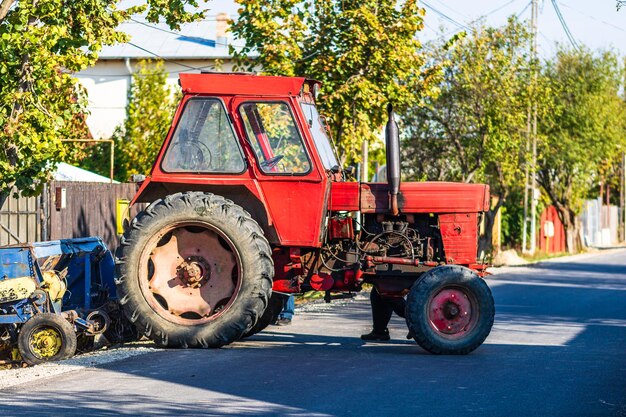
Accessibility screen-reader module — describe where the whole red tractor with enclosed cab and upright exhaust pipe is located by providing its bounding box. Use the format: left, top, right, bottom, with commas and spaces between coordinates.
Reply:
117, 74, 494, 354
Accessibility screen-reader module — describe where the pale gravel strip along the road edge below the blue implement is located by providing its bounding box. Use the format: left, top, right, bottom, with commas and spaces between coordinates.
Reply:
0, 347, 157, 390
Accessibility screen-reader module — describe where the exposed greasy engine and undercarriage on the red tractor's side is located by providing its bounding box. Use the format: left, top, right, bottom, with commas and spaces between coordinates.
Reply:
275, 213, 446, 293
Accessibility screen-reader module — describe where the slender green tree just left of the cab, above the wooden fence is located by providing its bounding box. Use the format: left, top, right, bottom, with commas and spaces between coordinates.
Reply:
81, 60, 178, 181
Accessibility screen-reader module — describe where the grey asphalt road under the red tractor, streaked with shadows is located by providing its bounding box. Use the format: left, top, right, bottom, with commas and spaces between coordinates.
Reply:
0, 250, 626, 416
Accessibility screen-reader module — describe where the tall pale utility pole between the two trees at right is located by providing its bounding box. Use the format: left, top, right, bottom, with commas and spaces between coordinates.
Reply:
529, 0, 539, 255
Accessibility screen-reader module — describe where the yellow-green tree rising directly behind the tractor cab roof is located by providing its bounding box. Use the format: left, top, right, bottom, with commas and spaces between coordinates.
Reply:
231, 0, 437, 166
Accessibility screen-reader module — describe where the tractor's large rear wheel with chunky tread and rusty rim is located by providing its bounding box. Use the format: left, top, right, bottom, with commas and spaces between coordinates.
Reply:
116, 192, 274, 348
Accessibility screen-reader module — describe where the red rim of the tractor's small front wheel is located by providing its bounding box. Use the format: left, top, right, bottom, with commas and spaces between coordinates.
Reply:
428, 287, 479, 339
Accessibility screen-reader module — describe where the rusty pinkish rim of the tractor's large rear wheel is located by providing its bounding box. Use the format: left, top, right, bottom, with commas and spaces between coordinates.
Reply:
139, 222, 241, 325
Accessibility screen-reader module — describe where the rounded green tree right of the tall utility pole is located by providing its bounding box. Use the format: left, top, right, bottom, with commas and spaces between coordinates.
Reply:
537, 48, 626, 253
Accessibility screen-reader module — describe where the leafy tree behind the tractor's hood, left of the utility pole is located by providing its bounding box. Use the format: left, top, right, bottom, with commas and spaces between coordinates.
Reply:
403, 18, 531, 255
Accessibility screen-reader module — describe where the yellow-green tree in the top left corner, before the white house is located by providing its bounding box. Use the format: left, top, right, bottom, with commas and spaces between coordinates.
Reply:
0, 0, 202, 203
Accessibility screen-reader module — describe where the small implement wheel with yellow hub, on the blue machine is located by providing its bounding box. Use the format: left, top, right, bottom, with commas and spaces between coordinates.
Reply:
17, 313, 77, 365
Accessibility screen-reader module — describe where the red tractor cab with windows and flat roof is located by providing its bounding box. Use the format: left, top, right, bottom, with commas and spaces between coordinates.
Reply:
134, 74, 340, 247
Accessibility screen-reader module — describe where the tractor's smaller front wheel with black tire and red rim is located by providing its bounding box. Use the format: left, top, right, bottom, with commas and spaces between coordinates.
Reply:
406, 265, 495, 355
